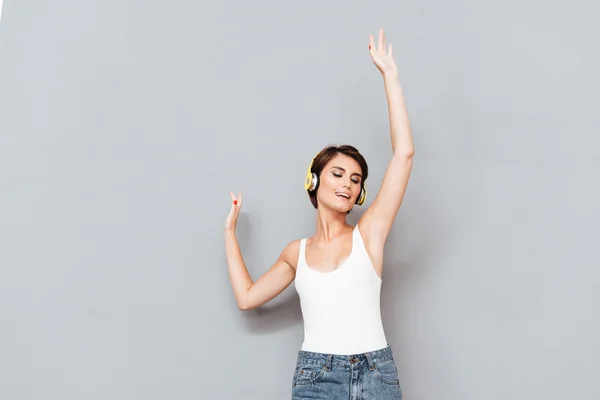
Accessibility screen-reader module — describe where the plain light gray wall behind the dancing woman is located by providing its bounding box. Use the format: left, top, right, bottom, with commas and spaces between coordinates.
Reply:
0, 0, 600, 400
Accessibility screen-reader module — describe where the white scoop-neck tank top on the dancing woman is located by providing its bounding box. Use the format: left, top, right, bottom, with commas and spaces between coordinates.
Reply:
295, 224, 387, 355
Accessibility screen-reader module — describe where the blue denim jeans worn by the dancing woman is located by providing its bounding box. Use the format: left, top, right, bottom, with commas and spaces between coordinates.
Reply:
292, 345, 402, 400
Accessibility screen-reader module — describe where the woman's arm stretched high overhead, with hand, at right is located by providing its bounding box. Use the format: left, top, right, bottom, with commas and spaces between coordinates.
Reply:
359, 29, 414, 253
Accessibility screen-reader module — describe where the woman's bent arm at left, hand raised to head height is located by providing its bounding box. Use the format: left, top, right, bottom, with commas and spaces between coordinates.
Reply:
224, 194, 300, 311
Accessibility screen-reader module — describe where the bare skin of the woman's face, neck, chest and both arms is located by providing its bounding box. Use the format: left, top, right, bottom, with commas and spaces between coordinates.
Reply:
224, 29, 414, 310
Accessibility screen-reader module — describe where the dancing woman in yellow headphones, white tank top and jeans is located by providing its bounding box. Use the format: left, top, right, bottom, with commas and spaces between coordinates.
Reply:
225, 29, 414, 400
